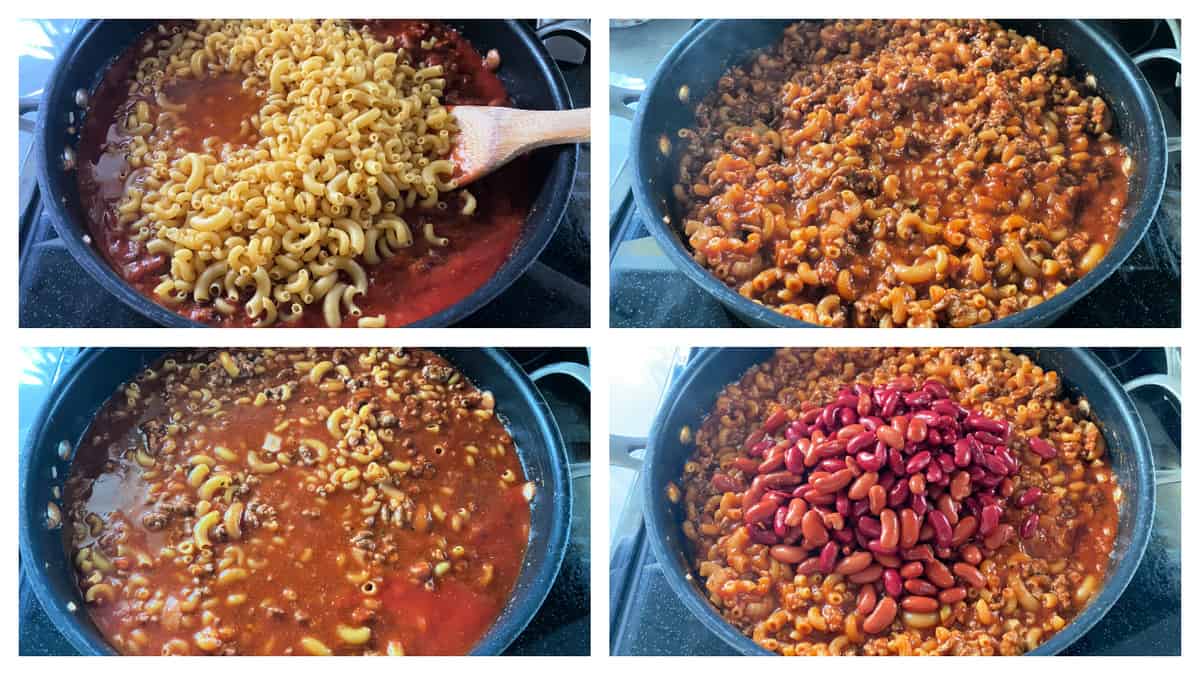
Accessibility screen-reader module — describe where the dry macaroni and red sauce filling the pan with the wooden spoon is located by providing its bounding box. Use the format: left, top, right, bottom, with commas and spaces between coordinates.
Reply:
78, 20, 530, 327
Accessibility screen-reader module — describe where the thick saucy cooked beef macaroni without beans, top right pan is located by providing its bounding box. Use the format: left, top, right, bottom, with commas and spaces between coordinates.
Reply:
674, 20, 1132, 327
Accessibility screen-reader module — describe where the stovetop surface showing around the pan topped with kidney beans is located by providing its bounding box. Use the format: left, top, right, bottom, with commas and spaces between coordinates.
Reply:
608, 348, 1182, 656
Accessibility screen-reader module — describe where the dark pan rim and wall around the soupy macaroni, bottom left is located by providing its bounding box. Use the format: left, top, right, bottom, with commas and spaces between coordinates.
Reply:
18, 348, 574, 656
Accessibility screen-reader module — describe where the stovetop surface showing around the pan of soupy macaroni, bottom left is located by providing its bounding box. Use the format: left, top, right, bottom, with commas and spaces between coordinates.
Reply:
18, 348, 592, 656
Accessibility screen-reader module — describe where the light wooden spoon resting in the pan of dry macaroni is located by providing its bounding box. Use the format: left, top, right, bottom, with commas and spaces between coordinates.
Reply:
451, 106, 592, 186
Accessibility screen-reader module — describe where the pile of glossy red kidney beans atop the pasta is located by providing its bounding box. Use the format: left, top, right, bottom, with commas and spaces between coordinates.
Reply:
713, 376, 1057, 633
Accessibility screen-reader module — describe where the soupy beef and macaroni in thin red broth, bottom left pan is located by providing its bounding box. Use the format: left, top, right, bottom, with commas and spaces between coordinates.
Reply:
65, 348, 534, 655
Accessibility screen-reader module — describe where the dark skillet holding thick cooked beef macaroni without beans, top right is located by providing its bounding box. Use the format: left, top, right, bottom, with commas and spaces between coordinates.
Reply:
631, 19, 1166, 328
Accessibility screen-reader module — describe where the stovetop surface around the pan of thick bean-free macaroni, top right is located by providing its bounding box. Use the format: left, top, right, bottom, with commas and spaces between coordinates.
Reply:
608, 19, 1182, 328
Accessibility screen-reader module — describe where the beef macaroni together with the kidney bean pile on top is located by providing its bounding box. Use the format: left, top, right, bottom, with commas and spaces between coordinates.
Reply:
681, 348, 1122, 655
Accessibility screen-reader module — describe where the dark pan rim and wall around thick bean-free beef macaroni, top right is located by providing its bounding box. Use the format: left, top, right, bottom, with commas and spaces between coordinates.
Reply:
630, 19, 1168, 328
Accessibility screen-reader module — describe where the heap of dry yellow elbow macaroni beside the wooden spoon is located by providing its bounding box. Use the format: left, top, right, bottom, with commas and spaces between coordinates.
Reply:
116, 20, 476, 327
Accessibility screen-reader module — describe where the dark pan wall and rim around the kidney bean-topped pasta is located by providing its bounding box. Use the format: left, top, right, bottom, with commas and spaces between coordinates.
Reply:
642, 348, 1156, 656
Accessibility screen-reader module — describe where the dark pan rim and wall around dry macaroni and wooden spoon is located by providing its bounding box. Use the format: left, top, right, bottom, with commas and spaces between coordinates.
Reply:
32, 19, 580, 328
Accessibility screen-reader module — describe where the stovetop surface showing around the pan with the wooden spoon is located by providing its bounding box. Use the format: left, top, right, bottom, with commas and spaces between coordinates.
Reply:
18, 19, 592, 328
